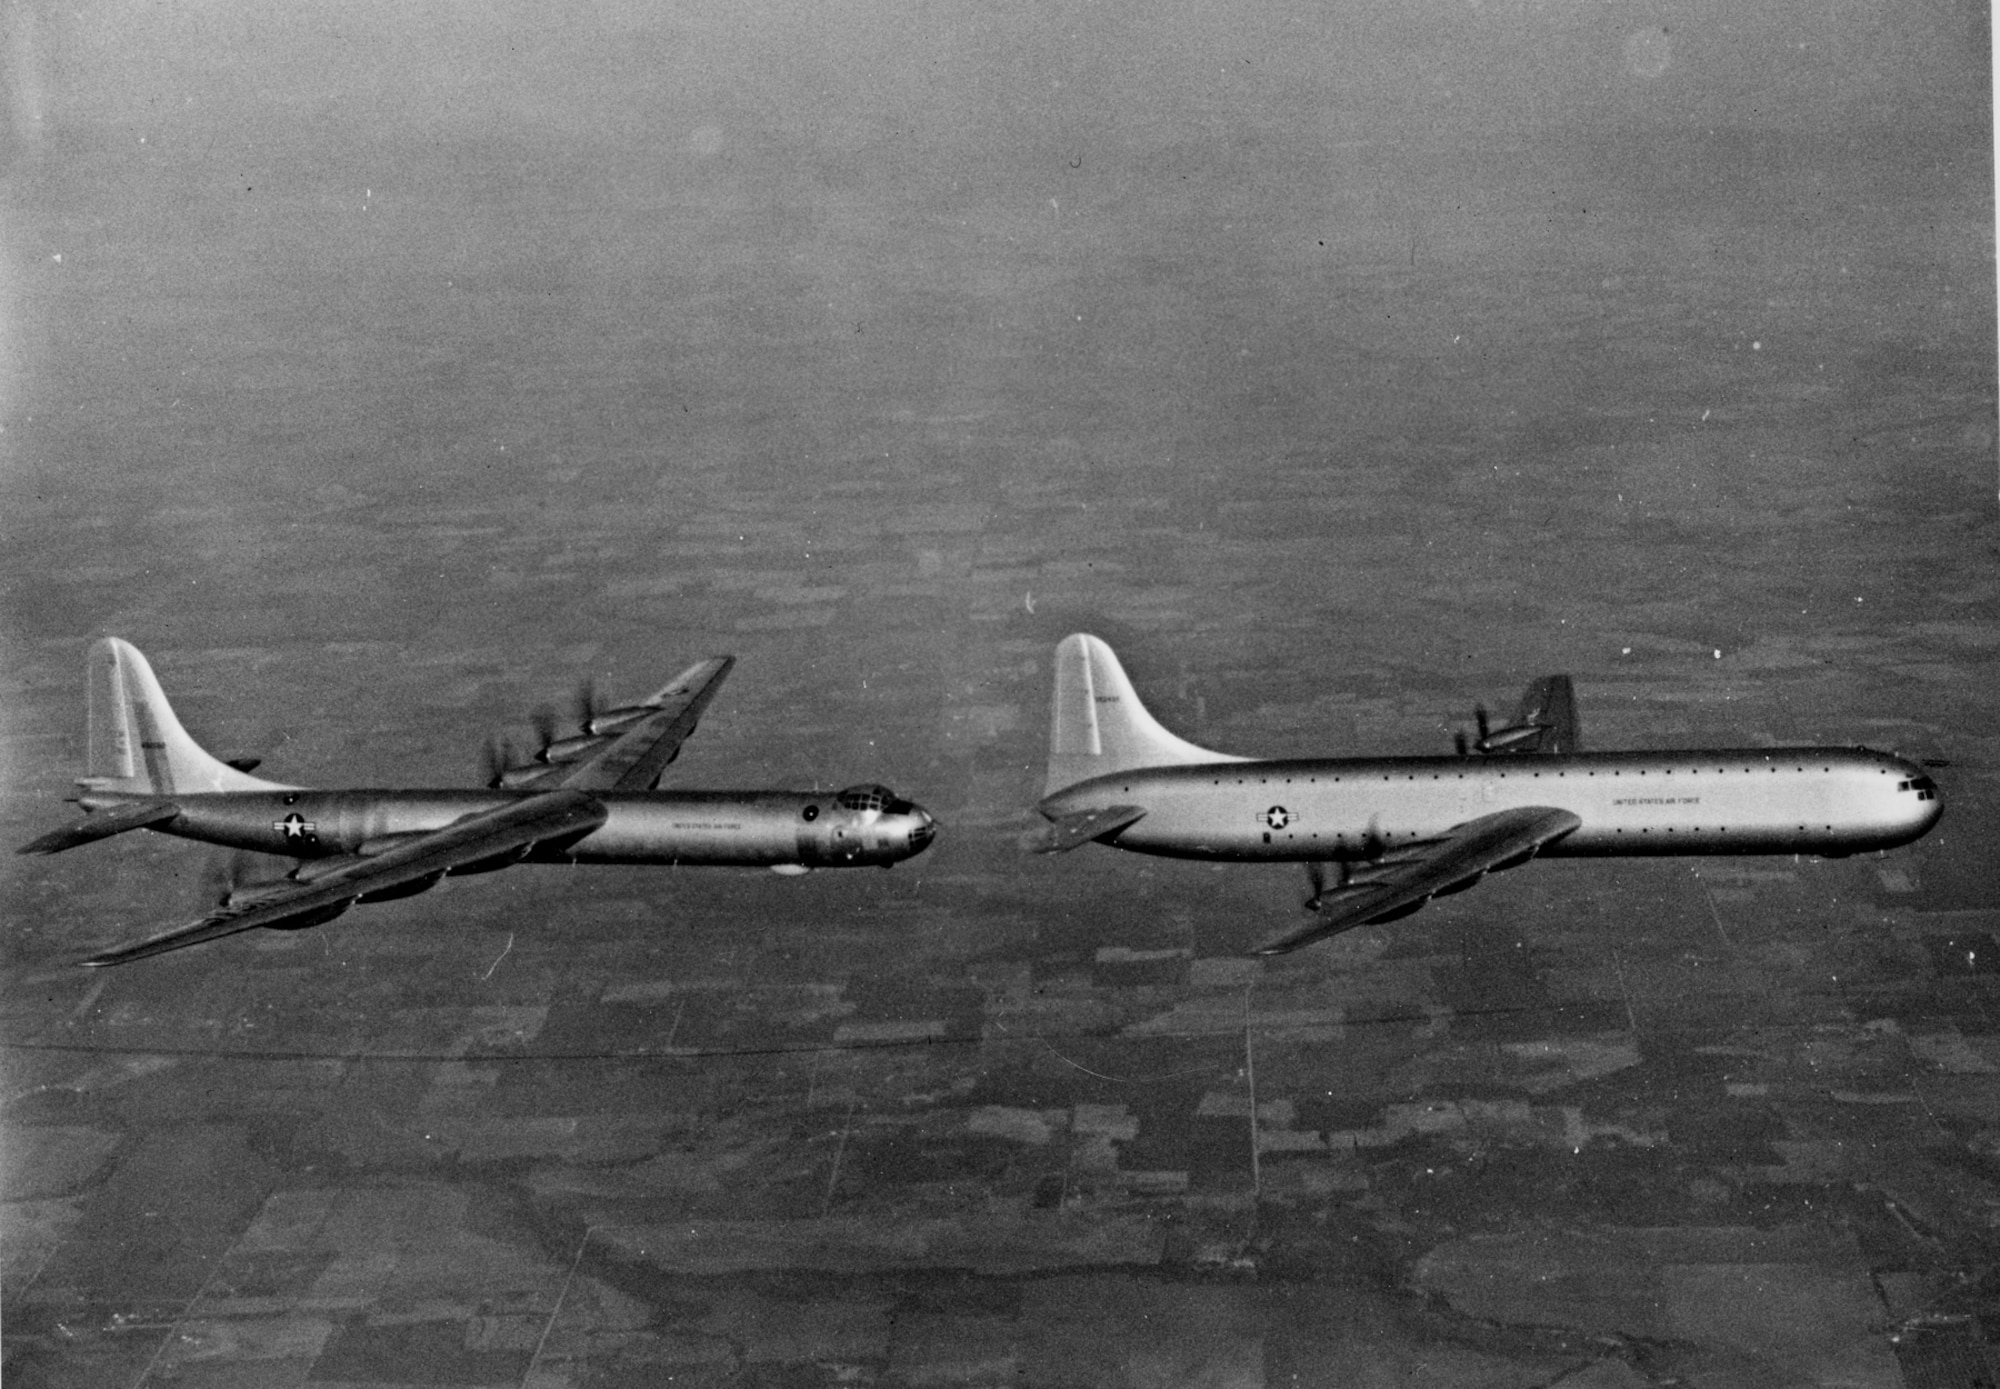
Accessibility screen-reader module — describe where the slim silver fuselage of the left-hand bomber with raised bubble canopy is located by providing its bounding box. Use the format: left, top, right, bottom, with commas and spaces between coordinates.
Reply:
82, 789, 936, 869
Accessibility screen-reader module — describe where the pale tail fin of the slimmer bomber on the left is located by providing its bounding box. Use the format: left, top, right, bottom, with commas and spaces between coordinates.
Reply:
78, 636, 290, 797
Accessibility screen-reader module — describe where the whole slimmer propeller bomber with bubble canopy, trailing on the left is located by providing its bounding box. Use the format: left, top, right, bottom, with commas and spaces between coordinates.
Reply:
20, 636, 938, 965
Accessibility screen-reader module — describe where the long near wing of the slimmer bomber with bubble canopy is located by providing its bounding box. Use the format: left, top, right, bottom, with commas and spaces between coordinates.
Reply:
84, 791, 606, 967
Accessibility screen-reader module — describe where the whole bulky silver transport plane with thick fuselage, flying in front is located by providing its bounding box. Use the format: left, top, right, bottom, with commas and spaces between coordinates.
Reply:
1036, 632, 1944, 955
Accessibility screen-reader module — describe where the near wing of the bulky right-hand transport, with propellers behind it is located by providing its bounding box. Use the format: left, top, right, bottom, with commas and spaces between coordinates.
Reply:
1254, 807, 1582, 955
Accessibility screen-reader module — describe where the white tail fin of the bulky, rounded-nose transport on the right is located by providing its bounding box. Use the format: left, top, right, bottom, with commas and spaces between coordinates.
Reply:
1042, 632, 1246, 797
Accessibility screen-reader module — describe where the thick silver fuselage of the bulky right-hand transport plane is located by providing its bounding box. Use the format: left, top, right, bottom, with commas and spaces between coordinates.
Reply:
1040, 747, 1944, 863
